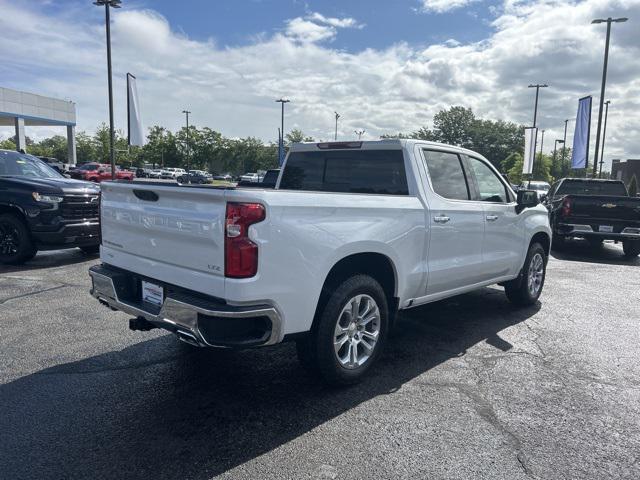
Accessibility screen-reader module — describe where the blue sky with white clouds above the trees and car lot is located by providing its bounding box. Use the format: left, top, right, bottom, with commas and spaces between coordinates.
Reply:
0, 0, 640, 169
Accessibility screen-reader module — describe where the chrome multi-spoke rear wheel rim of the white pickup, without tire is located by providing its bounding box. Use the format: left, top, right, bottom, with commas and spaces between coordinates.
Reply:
333, 294, 380, 368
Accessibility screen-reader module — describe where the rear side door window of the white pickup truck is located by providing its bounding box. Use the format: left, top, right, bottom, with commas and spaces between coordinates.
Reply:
424, 150, 470, 200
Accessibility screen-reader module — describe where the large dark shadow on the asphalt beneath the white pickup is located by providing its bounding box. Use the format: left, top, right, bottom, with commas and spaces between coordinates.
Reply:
0, 288, 540, 479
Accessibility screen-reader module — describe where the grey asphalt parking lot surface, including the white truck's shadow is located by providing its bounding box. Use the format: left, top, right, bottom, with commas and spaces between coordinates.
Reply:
0, 244, 640, 479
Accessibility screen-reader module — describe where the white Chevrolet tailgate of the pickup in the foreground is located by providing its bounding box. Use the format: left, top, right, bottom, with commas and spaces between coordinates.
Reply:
101, 182, 226, 284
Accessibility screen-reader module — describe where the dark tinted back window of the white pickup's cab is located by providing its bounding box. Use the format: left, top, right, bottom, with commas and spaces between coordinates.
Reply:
280, 150, 409, 195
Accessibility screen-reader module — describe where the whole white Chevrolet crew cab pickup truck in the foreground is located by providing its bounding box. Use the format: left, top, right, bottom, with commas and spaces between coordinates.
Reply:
90, 140, 551, 384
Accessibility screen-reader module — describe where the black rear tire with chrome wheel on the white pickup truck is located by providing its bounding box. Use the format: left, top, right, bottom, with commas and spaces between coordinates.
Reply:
297, 275, 389, 386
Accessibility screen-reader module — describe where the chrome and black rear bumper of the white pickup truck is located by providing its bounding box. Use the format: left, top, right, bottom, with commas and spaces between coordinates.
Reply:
89, 265, 283, 348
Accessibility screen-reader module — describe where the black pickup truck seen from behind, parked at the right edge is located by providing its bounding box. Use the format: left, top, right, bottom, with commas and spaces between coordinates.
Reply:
544, 178, 640, 258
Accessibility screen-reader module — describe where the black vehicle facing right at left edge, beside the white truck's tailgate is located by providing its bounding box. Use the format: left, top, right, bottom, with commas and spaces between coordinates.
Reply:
0, 150, 100, 264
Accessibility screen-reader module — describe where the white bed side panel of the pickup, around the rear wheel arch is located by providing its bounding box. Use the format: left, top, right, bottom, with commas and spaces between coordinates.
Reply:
225, 190, 426, 333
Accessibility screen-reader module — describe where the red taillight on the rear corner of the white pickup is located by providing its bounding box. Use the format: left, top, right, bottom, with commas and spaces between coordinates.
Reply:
224, 203, 265, 278
